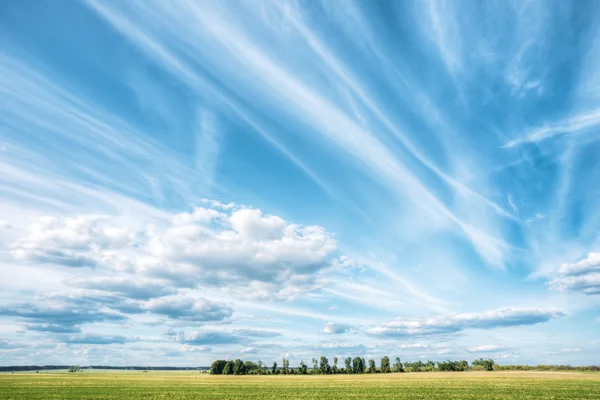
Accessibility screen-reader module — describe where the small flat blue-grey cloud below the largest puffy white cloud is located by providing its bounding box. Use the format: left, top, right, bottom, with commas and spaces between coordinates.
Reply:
144, 296, 233, 322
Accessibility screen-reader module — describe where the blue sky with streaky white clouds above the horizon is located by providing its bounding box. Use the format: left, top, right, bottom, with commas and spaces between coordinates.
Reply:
0, 0, 600, 365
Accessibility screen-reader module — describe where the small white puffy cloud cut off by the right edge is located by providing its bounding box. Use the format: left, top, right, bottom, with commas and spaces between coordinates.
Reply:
548, 253, 600, 295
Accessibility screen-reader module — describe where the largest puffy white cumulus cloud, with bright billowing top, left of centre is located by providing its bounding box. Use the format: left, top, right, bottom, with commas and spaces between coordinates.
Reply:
139, 207, 337, 299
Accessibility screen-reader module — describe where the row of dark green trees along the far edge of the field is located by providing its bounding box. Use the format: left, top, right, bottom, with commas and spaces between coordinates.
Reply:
210, 356, 496, 375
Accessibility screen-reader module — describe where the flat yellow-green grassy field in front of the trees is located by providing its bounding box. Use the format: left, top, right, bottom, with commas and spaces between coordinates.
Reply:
0, 371, 600, 400
